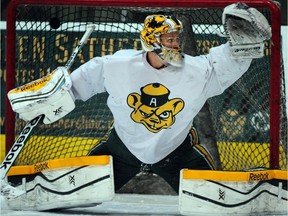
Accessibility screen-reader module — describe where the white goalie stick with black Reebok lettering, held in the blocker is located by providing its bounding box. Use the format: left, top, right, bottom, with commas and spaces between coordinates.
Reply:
0, 24, 96, 196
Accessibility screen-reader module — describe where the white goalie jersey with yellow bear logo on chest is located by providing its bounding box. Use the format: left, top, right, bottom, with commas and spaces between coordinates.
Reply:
71, 44, 251, 164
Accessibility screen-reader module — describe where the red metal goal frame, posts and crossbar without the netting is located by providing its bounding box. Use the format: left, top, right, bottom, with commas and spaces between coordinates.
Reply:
5, 0, 281, 169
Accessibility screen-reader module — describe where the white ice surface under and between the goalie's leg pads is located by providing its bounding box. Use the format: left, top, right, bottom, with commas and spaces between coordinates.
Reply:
0, 194, 180, 216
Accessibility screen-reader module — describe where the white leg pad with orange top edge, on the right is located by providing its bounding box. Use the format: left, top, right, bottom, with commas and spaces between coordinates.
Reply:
179, 170, 288, 216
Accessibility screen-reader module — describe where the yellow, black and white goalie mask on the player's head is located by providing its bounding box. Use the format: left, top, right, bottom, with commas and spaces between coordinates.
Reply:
140, 15, 183, 67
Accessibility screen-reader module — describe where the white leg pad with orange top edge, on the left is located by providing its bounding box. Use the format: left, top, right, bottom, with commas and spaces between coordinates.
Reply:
8, 156, 115, 211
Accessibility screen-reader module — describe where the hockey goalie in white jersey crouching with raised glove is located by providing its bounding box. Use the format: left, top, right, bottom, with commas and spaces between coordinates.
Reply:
2, 3, 287, 214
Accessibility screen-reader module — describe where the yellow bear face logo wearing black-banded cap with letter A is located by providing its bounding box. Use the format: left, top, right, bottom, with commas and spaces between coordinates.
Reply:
127, 83, 184, 133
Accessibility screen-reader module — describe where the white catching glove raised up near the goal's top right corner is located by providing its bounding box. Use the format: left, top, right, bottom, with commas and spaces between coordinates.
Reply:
222, 2, 271, 59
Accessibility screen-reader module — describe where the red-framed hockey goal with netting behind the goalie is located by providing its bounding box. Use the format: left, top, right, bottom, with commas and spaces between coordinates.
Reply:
6, 0, 287, 170
